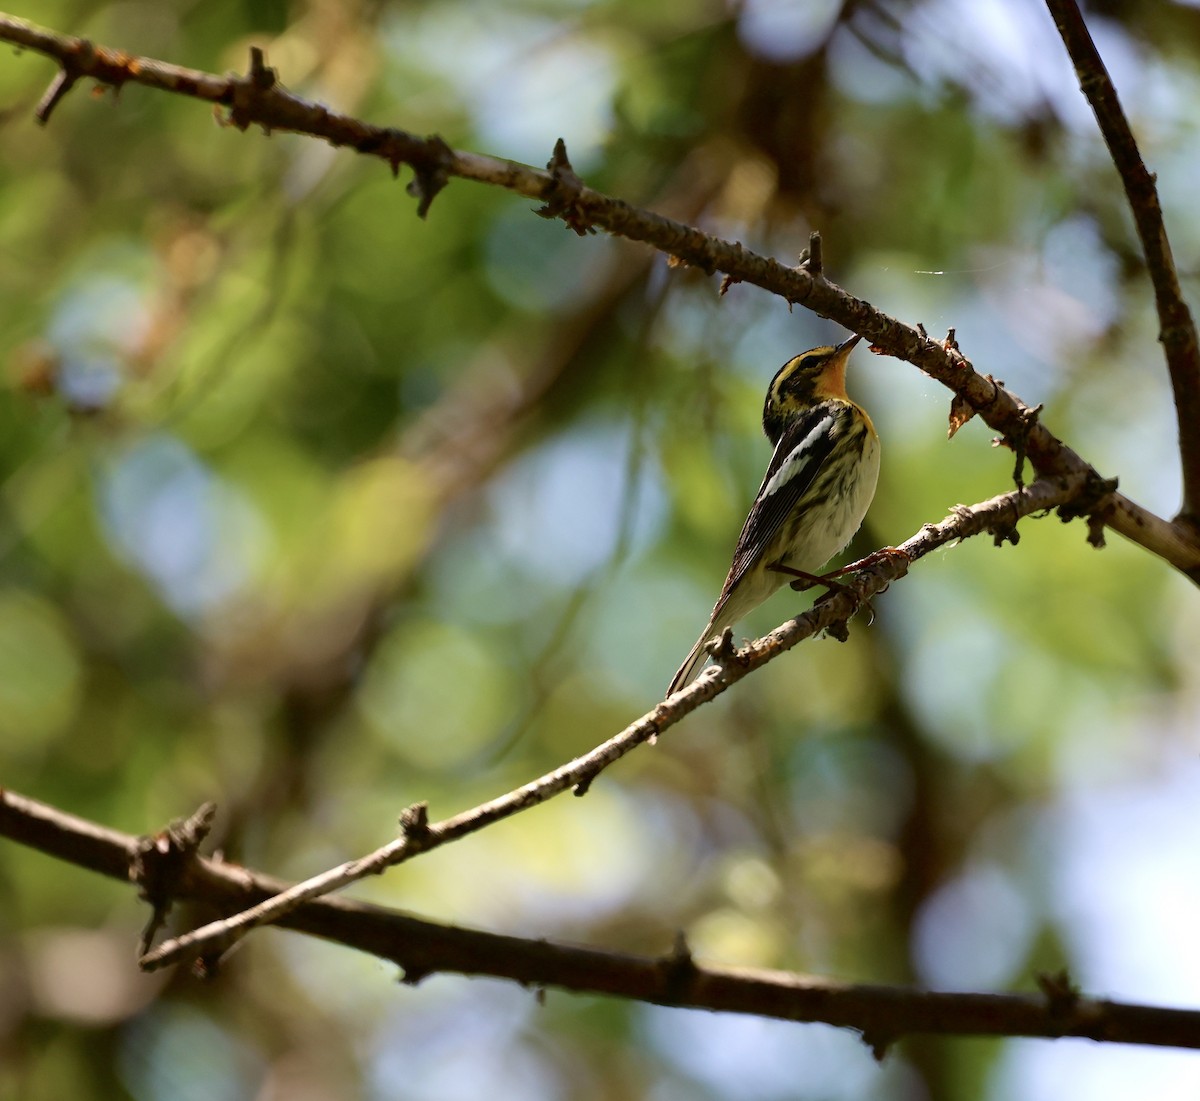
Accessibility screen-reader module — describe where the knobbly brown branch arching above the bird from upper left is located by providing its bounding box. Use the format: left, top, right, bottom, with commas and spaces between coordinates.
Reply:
0, 14, 1200, 584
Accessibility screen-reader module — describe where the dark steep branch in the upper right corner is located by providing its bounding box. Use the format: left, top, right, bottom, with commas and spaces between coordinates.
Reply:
1046, 0, 1200, 527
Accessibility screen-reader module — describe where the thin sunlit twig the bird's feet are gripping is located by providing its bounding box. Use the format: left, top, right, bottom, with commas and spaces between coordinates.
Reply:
140, 476, 1087, 970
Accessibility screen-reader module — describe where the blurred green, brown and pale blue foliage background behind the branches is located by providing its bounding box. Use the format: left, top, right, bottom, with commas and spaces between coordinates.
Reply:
0, 0, 1200, 1101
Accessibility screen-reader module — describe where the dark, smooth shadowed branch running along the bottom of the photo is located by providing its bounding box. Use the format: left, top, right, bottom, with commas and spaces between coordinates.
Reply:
0, 790, 1200, 1054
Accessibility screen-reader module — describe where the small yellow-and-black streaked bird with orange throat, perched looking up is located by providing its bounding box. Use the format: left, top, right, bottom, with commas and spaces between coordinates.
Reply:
667, 335, 880, 696
